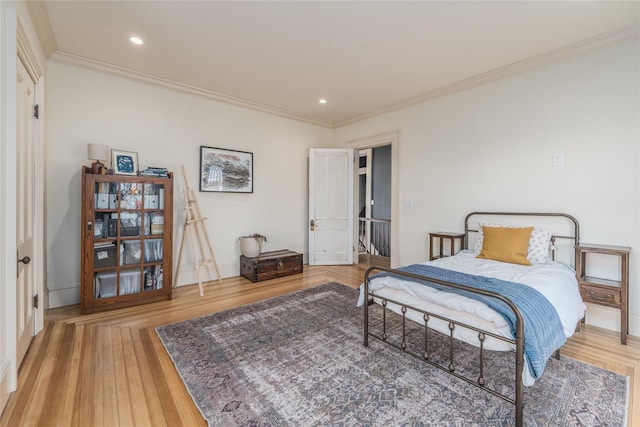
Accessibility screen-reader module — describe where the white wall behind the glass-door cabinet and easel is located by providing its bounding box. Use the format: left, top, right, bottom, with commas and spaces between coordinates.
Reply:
47, 55, 332, 307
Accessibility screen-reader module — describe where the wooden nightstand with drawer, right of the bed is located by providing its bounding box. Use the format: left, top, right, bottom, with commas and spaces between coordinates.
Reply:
576, 243, 631, 344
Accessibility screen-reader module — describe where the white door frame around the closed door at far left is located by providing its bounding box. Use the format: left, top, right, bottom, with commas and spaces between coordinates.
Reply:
0, 8, 46, 410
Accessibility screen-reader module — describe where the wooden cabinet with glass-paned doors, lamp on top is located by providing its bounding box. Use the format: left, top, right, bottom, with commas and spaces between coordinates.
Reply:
80, 167, 173, 313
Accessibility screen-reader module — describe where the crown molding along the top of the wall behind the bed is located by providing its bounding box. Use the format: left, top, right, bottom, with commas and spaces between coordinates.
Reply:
333, 25, 640, 128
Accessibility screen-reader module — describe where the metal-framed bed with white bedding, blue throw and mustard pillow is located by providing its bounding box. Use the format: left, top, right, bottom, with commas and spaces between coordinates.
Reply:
358, 212, 586, 427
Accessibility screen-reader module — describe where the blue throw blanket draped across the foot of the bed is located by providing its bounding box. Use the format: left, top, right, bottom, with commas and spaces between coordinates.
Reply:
373, 264, 567, 379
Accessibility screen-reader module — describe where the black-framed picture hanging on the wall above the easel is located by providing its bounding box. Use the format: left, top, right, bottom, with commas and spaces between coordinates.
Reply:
200, 146, 253, 193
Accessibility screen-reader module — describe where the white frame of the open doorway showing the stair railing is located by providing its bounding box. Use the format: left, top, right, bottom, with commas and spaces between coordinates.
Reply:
346, 129, 400, 267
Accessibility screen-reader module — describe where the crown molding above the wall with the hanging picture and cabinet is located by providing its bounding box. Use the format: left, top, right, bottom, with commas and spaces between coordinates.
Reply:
51, 51, 333, 128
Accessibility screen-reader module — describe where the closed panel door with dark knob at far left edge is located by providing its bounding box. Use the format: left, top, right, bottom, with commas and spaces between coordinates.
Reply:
16, 60, 36, 366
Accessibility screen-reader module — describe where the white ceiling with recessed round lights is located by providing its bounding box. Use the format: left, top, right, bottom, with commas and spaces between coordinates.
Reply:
38, 0, 640, 127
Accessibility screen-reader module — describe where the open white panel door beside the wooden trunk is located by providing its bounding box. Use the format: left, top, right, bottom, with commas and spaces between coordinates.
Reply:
308, 148, 354, 265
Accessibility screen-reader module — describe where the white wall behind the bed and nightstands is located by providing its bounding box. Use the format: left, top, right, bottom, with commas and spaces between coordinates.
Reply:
334, 40, 640, 335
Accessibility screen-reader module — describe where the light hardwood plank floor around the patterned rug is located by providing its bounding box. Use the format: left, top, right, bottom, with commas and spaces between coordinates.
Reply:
0, 264, 640, 427
